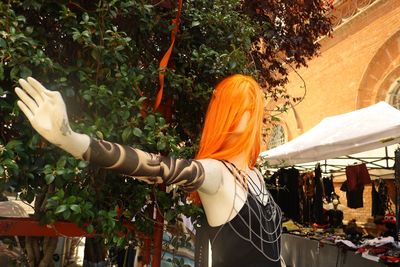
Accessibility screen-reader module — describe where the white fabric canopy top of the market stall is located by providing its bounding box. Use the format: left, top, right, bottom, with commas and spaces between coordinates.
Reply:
261, 102, 400, 167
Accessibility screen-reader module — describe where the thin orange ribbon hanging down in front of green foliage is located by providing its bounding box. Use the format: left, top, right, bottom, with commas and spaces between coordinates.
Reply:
153, 0, 182, 110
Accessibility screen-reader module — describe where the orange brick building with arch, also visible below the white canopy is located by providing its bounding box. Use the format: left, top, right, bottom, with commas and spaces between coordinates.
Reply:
269, 0, 400, 229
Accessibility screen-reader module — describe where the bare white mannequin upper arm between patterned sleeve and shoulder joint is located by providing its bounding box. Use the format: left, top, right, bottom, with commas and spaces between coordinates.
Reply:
197, 159, 224, 195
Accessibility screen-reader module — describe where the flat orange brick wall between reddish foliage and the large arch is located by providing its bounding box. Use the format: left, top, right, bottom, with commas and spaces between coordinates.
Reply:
269, 0, 400, 141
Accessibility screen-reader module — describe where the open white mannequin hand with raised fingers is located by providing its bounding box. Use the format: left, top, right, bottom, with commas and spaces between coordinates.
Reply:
15, 77, 90, 158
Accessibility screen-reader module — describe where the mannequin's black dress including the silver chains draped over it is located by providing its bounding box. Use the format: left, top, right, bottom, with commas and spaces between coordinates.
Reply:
207, 166, 282, 267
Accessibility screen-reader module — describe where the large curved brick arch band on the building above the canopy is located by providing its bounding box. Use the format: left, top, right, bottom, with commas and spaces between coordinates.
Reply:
356, 30, 400, 109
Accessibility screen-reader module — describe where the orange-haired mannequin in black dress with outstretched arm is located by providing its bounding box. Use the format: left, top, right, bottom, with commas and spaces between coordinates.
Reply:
15, 74, 281, 267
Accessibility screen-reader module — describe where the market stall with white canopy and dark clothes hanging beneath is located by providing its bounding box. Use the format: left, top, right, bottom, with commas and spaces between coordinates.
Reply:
261, 102, 400, 266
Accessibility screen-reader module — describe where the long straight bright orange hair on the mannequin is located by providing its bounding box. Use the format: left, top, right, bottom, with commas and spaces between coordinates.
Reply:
190, 74, 264, 202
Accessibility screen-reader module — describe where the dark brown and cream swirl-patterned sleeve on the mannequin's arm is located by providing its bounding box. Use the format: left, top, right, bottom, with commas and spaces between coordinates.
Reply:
83, 139, 204, 192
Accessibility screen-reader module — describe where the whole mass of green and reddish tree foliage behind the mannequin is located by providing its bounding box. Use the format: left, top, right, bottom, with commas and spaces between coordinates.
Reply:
0, 0, 331, 258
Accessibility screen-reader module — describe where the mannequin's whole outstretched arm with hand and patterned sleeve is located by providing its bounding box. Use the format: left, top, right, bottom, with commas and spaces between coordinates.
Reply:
15, 78, 221, 193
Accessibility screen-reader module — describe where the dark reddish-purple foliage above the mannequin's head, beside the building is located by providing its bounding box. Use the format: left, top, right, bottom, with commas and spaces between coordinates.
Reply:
243, 0, 333, 91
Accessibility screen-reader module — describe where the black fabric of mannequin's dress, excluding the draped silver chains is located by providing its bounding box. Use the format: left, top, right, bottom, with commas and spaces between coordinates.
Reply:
208, 193, 281, 267
